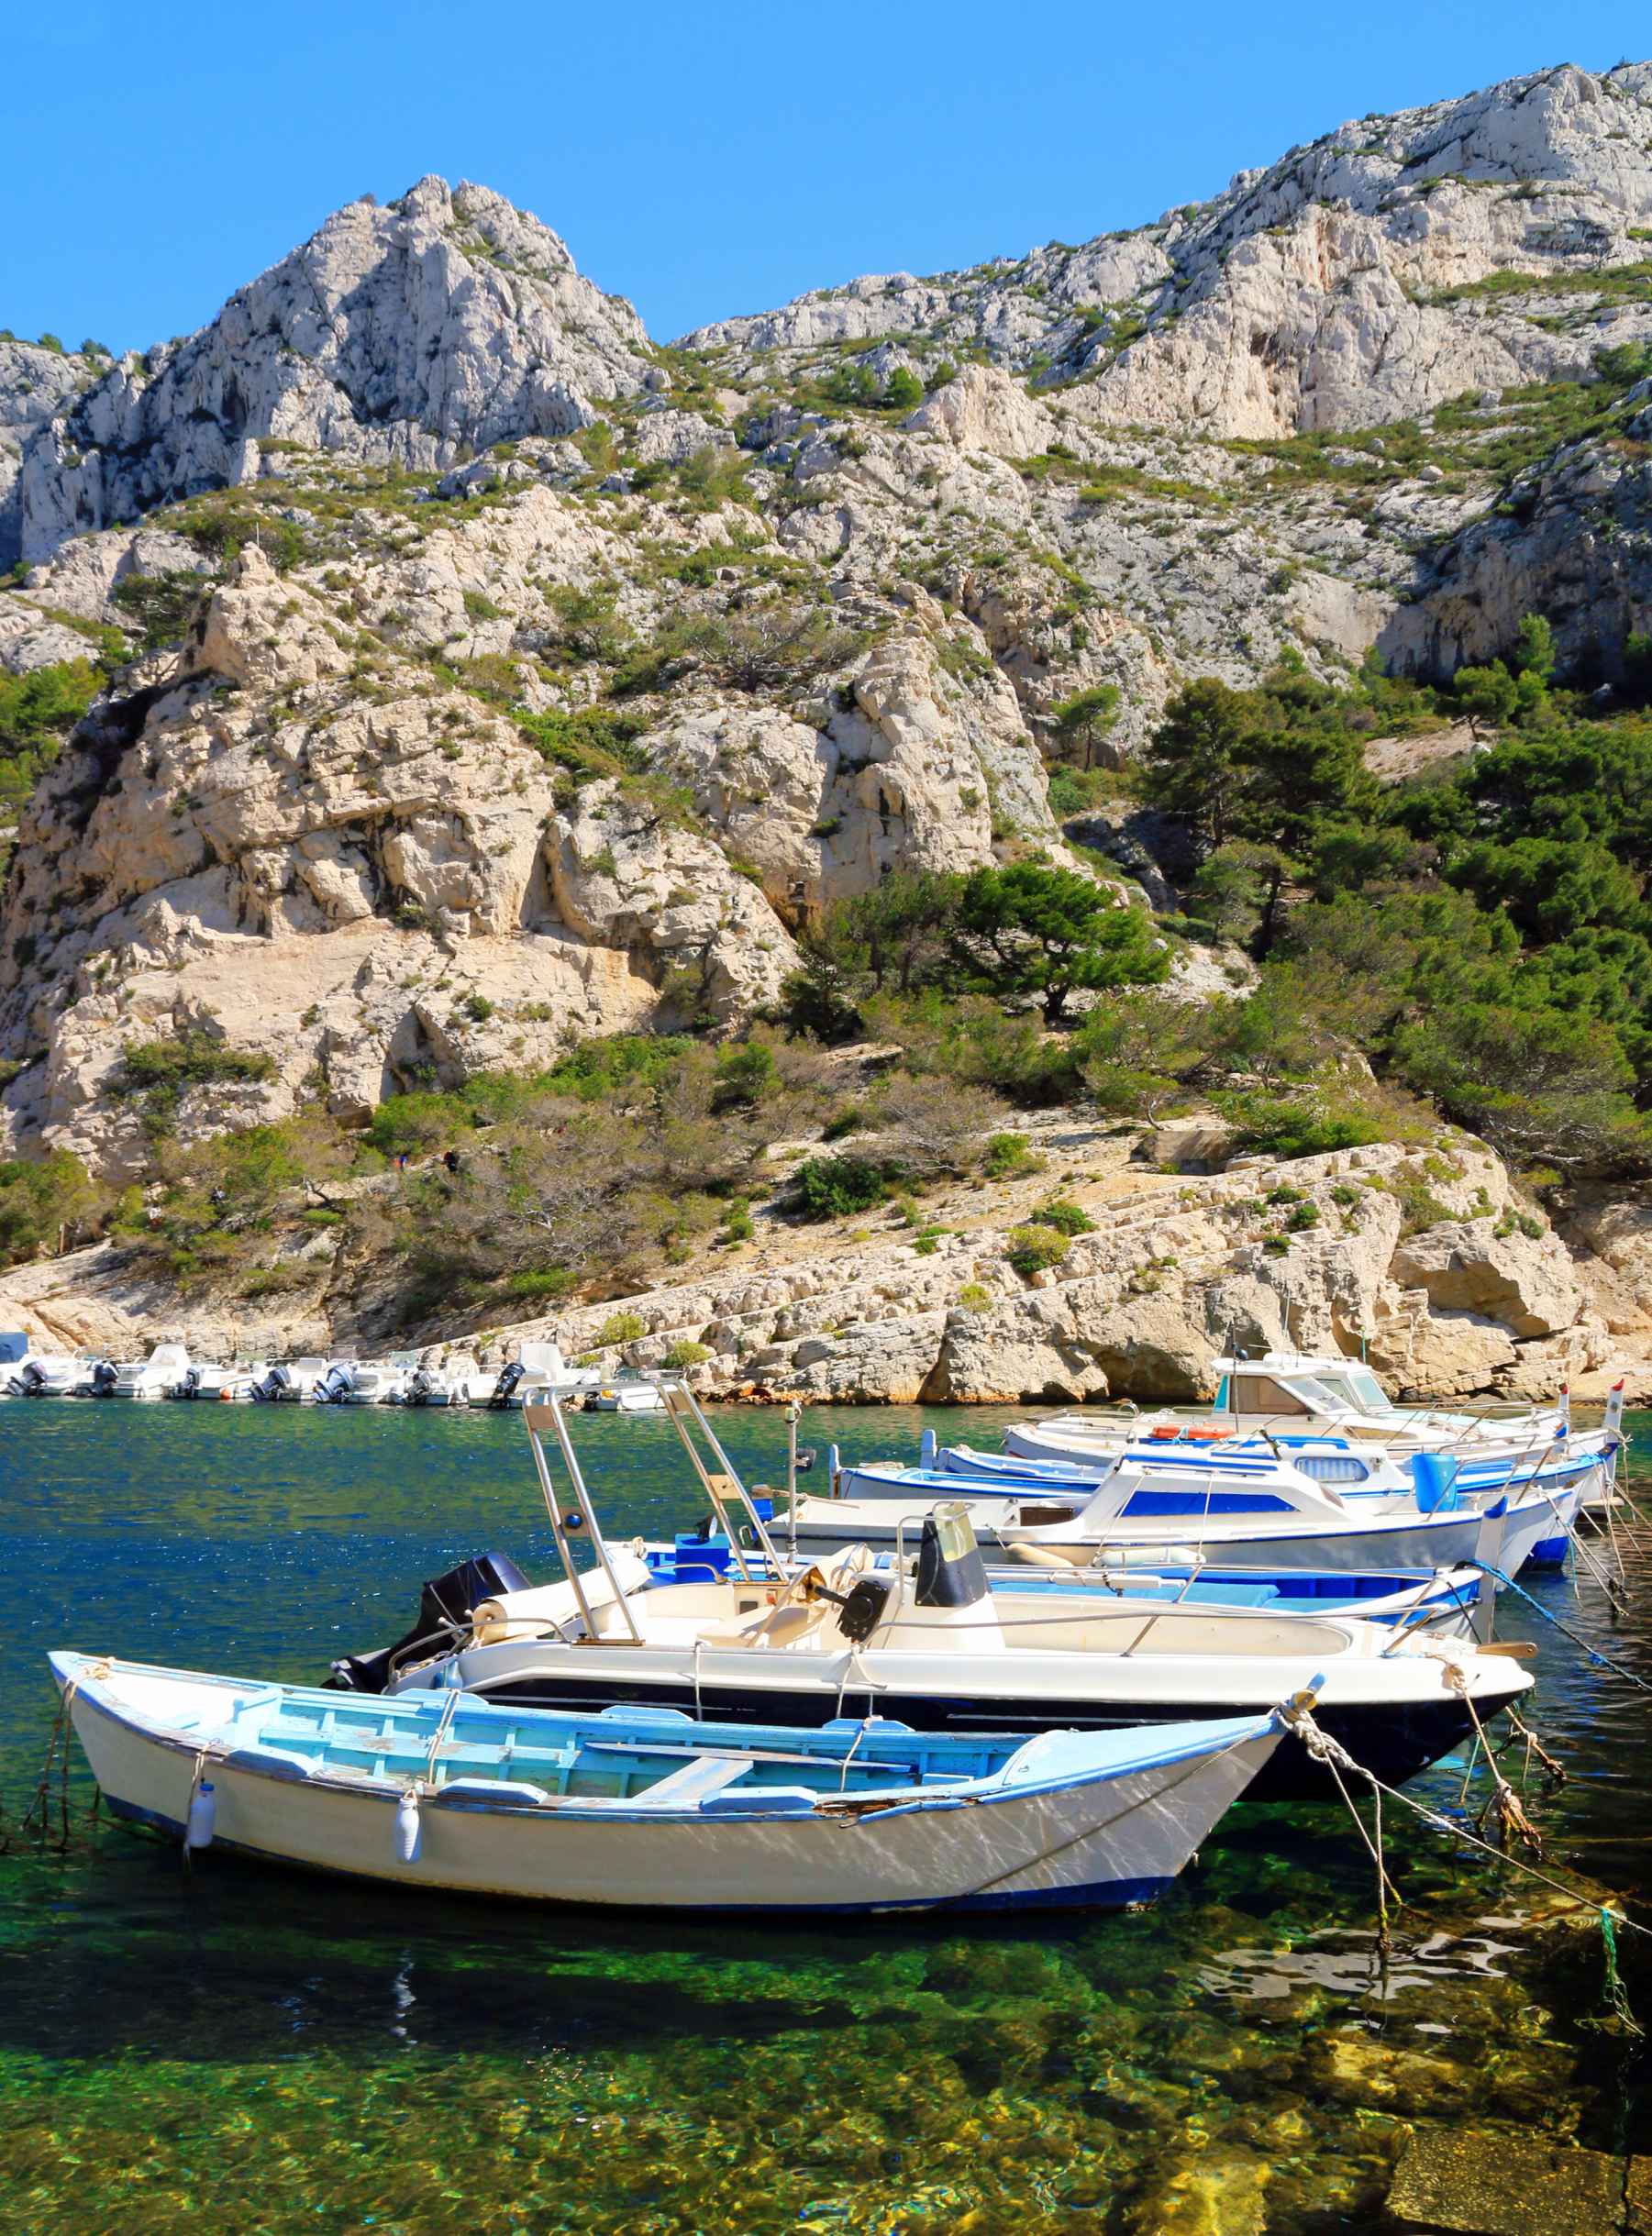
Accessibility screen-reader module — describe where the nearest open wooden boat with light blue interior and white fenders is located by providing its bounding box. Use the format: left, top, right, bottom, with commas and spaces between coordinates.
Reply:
51, 1653, 1283, 1914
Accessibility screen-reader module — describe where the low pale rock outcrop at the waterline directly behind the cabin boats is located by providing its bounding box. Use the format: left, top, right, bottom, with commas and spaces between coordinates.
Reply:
469, 1120, 1652, 1404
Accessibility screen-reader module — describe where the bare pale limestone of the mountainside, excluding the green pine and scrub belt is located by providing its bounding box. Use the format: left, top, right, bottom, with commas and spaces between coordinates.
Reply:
0, 65, 1652, 1393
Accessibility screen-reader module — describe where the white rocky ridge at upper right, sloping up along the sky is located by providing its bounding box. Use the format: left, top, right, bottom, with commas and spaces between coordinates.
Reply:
689, 62, 1652, 440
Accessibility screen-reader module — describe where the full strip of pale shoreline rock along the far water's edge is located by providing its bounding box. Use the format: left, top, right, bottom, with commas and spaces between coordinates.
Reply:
0, 1113, 1652, 1404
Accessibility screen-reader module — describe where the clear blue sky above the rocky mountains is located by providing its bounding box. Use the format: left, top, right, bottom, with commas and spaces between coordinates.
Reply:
0, 0, 1652, 349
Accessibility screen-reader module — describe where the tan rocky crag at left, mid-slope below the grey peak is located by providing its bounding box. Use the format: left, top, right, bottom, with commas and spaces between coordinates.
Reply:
0, 550, 796, 1172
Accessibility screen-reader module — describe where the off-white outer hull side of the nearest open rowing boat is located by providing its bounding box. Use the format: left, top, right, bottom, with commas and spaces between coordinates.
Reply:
53, 1657, 1277, 1916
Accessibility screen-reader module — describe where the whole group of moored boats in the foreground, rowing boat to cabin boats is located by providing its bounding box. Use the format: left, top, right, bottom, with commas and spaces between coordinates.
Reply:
51, 1353, 1645, 1916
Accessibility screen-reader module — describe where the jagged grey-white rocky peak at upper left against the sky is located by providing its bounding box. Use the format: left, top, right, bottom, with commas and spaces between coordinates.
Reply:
17, 179, 649, 559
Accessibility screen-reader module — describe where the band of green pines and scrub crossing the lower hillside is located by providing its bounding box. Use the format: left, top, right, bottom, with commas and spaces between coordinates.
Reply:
0, 619, 1652, 1326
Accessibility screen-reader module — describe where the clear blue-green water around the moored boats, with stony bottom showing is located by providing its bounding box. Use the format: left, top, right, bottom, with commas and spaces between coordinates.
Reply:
0, 1404, 1652, 2236
